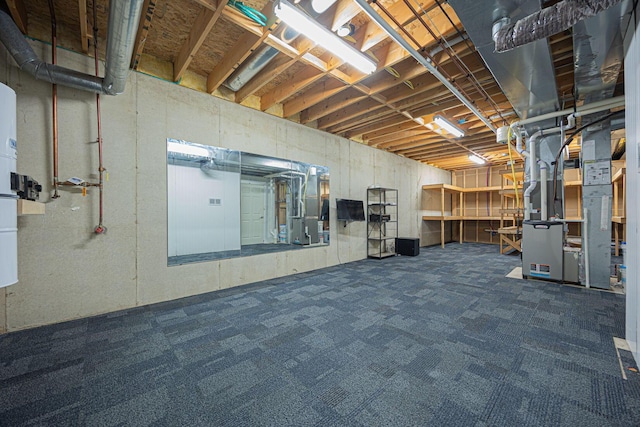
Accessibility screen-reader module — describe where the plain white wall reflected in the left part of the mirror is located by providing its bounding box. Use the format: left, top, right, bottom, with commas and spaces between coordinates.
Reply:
167, 165, 240, 256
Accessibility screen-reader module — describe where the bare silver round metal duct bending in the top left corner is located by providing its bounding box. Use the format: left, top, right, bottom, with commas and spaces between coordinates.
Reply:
0, 0, 144, 95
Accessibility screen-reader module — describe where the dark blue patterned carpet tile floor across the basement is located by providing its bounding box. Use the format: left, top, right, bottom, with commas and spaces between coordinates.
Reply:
0, 244, 640, 427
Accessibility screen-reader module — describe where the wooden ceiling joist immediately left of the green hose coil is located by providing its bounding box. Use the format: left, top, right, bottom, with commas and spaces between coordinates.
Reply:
173, 0, 227, 82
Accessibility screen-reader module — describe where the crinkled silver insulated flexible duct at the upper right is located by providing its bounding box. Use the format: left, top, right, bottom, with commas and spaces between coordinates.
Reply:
494, 0, 621, 52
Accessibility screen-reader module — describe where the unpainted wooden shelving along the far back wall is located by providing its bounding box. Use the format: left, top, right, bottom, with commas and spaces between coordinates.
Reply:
422, 161, 626, 255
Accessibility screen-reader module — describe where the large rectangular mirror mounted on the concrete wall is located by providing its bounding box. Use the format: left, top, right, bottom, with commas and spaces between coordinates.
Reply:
167, 139, 329, 266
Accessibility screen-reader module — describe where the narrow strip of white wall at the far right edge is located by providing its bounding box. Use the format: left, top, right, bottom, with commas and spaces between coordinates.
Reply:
624, 12, 640, 363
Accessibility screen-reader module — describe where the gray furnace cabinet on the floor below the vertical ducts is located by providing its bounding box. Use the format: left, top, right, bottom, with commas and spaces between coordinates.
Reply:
522, 220, 564, 282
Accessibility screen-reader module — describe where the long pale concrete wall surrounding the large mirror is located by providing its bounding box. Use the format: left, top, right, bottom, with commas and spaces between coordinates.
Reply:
0, 42, 451, 330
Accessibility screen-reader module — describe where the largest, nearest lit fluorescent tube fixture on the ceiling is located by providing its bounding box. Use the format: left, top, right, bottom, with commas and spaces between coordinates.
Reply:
273, 0, 376, 74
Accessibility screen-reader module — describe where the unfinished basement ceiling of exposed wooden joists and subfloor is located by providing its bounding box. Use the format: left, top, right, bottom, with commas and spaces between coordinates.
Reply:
1, 0, 626, 170
